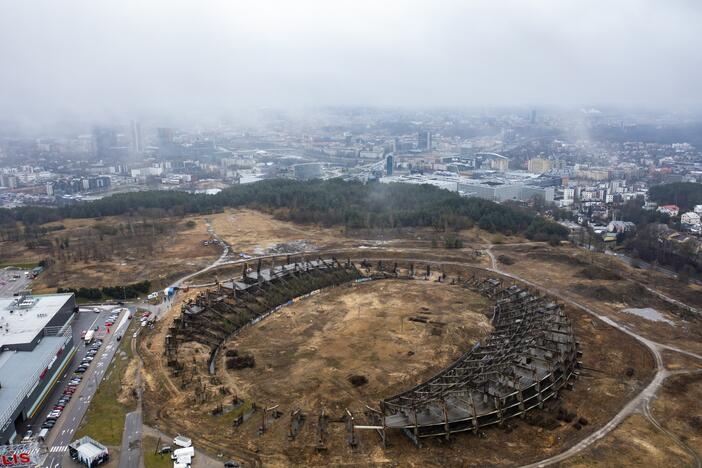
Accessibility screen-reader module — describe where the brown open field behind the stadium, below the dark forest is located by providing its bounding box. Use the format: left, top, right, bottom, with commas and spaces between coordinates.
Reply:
5, 209, 498, 293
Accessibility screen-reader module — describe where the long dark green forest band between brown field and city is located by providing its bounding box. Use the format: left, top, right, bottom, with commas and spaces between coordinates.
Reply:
0, 179, 568, 240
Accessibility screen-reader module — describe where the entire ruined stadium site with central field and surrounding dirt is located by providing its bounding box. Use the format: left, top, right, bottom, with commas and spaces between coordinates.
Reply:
140, 253, 653, 466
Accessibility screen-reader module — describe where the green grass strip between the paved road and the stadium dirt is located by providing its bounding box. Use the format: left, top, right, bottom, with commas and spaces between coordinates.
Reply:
75, 319, 139, 446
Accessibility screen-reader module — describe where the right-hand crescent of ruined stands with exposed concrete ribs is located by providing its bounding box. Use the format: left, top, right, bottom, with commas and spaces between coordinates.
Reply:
379, 277, 580, 445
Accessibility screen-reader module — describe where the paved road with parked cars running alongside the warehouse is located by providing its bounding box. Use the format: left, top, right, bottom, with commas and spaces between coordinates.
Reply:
42, 307, 135, 468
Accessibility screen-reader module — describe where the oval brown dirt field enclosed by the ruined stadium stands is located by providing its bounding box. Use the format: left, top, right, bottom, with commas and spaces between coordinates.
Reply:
219, 280, 490, 413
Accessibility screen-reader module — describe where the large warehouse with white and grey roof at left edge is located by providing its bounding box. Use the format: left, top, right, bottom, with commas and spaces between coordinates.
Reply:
0, 294, 76, 444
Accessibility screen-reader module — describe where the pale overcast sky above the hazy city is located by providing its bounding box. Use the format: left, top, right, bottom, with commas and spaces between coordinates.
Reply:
0, 0, 702, 123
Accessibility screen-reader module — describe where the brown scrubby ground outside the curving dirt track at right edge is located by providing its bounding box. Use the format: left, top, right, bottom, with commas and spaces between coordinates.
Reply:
486, 245, 702, 466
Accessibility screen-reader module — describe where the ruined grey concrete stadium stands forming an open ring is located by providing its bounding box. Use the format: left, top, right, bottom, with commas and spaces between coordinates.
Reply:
165, 256, 581, 446
